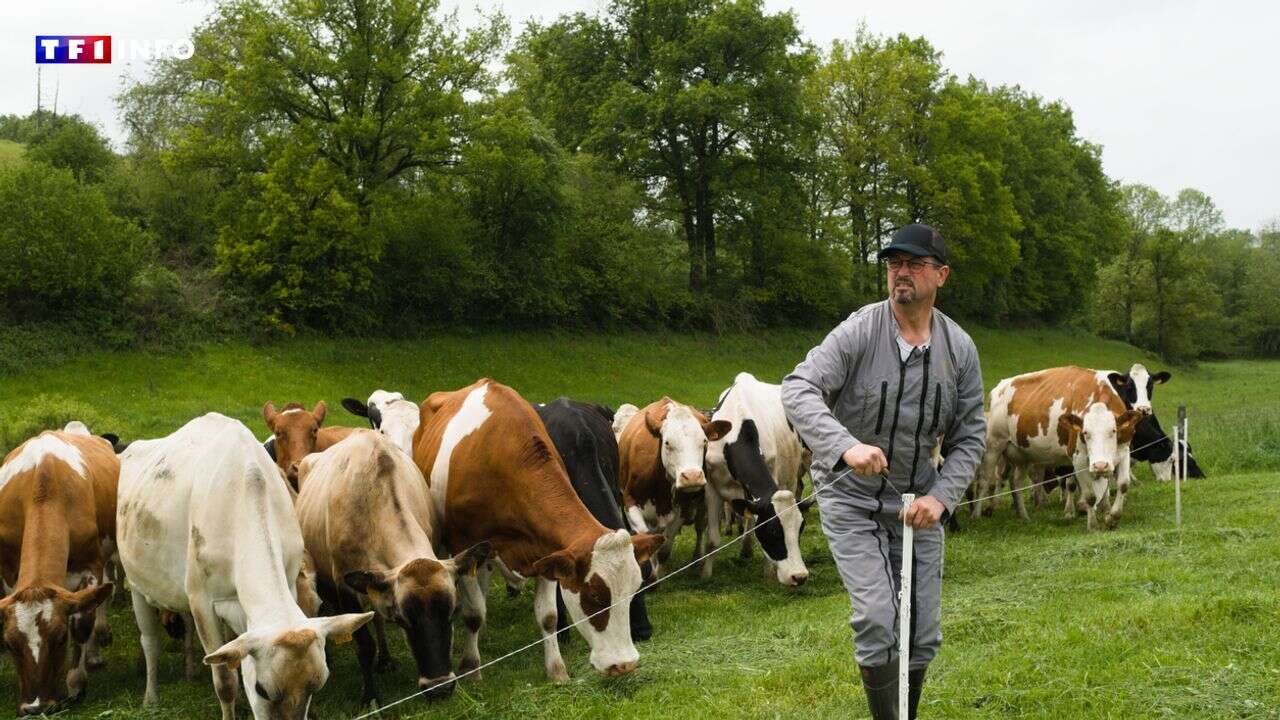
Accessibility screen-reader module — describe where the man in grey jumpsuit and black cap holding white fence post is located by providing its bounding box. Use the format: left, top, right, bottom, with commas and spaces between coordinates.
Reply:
782, 224, 986, 720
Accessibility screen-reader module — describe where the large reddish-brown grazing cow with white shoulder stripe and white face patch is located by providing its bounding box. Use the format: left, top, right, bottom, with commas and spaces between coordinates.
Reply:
413, 378, 662, 682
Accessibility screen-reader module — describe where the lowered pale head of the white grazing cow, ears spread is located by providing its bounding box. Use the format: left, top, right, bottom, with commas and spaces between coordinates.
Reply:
205, 612, 374, 720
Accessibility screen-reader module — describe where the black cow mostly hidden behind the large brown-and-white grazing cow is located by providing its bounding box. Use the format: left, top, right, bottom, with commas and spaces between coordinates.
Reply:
536, 397, 653, 641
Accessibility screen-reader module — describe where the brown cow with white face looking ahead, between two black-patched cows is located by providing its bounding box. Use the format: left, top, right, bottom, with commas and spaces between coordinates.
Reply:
618, 397, 732, 577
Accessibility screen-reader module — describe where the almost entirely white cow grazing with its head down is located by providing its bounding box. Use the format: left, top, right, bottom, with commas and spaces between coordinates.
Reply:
116, 413, 374, 720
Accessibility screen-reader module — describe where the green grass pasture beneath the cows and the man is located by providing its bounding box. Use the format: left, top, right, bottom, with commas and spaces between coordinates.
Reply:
0, 328, 1280, 719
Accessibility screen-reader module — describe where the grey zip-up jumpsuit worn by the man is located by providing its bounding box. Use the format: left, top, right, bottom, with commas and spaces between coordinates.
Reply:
782, 300, 986, 669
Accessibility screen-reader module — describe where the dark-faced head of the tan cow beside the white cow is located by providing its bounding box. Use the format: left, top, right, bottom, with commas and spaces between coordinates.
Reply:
343, 542, 490, 697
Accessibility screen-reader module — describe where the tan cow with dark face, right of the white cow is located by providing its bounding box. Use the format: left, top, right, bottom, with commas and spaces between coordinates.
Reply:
296, 429, 489, 706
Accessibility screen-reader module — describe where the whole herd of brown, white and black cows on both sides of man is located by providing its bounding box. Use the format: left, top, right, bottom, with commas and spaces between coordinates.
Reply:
0, 365, 1198, 720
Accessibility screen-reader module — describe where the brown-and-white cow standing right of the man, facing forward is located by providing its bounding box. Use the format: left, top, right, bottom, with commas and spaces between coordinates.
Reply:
973, 366, 1142, 529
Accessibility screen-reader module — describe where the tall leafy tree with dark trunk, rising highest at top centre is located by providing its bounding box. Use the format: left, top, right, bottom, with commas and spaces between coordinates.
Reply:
509, 0, 812, 292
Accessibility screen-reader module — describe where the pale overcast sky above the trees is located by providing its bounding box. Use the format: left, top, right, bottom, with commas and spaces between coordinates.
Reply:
0, 0, 1280, 229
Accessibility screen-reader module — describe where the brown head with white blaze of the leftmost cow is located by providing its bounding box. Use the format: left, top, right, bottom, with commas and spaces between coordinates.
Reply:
0, 583, 111, 715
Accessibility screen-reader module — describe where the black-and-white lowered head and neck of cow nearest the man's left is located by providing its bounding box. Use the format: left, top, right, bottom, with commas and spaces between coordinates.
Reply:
724, 418, 809, 585
